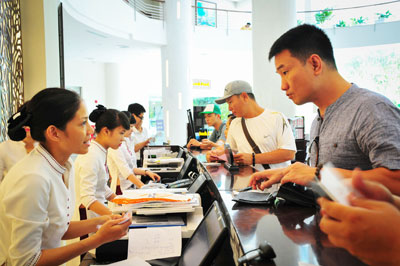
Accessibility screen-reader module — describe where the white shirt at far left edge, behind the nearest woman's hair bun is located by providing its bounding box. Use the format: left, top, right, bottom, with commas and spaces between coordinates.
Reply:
0, 140, 26, 182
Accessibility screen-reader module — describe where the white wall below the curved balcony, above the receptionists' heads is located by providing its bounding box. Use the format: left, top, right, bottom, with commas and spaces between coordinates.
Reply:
65, 50, 161, 130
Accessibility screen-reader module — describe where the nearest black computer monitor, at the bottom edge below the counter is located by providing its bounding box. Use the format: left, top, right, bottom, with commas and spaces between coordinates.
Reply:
178, 201, 228, 266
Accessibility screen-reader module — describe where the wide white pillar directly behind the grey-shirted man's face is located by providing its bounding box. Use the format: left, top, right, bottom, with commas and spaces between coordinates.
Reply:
252, 0, 296, 117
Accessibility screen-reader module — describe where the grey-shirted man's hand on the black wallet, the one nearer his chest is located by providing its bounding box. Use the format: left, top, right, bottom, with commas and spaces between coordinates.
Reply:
281, 162, 316, 186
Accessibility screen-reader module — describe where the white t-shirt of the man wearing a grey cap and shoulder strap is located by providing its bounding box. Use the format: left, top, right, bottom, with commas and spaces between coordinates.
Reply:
226, 109, 296, 168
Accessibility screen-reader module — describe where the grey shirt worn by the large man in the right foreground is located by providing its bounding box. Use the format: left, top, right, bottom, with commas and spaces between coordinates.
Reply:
310, 84, 400, 170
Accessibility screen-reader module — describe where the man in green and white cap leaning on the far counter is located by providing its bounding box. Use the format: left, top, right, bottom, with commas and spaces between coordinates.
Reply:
186, 104, 226, 150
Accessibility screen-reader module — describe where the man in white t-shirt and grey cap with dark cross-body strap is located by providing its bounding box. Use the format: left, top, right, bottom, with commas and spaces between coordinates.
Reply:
211, 80, 296, 168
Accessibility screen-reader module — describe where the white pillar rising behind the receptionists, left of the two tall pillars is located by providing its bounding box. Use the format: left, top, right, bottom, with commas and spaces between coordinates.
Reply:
161, 0, 193, 145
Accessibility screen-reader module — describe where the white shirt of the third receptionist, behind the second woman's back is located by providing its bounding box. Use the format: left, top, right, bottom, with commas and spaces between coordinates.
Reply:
107, 138, 136, 190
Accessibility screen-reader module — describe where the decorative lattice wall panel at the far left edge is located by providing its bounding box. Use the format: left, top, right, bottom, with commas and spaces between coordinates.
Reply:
0, 0, 24, 141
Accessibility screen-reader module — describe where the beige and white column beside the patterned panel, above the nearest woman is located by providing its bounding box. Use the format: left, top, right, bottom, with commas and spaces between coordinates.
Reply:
20, 0, 60, 101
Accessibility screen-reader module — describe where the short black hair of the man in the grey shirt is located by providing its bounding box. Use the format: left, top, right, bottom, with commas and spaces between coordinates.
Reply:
268, 24, 337, 69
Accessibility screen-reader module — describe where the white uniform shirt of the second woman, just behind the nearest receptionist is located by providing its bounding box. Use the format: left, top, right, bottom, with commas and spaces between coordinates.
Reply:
75, 141, 113, 218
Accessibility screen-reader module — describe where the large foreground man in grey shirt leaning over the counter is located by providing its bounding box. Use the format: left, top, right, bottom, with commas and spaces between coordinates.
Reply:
252, 24, 400, 195
